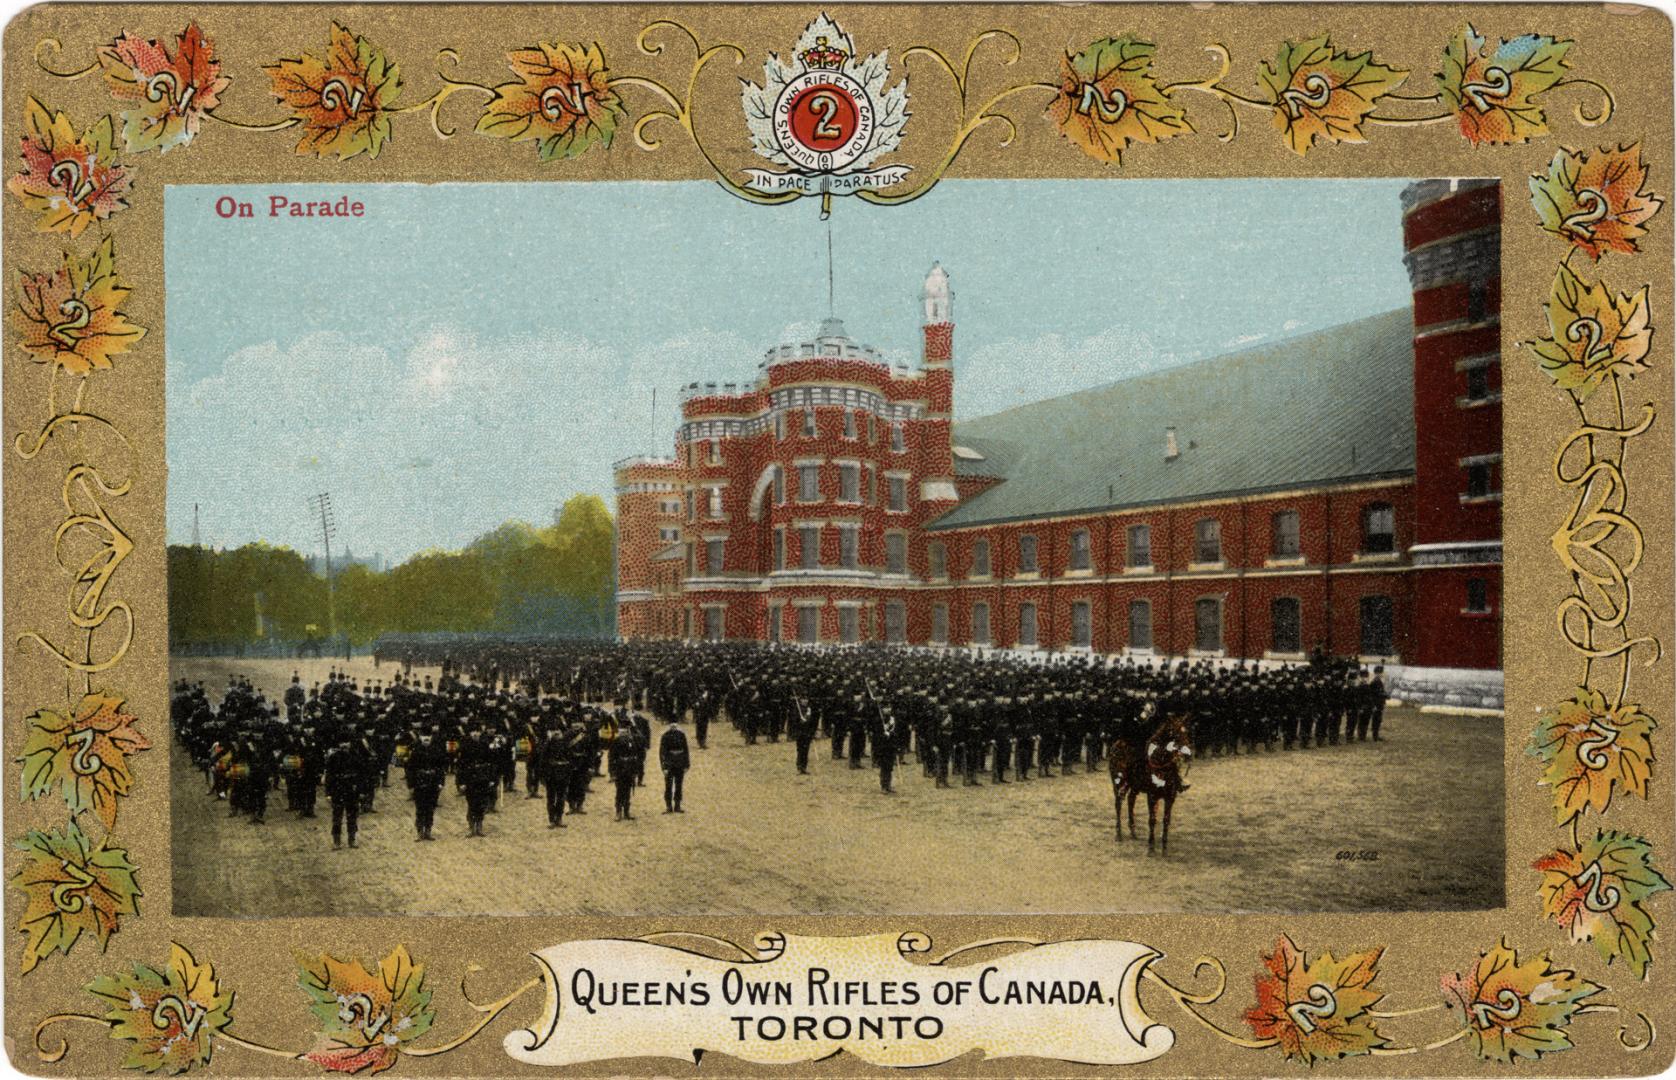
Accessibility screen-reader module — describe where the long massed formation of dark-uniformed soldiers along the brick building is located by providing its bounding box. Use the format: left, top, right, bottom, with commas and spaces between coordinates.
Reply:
375, 641, 1386, 792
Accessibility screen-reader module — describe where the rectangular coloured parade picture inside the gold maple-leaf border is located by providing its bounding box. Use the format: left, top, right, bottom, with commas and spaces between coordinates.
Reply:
166, 179, 1503, 917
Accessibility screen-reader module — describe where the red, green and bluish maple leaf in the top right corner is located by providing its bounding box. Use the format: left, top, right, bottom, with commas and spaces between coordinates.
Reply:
1436, 25, 1572, 146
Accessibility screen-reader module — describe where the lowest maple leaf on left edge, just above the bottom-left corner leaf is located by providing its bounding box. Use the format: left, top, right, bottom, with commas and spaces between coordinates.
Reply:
12, 820, 142, 974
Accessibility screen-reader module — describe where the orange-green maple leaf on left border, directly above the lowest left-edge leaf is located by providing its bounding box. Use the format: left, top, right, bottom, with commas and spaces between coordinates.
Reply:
18, 694, 151, 828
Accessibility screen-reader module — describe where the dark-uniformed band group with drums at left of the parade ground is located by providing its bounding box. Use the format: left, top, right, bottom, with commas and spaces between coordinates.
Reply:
171, 660, 667, 847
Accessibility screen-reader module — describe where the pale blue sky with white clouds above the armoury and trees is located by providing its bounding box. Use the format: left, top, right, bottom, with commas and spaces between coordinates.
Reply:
164, 179, 1408, 558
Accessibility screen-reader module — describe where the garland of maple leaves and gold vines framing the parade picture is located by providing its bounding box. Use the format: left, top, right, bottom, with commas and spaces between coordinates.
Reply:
7, 5, 1671, 1072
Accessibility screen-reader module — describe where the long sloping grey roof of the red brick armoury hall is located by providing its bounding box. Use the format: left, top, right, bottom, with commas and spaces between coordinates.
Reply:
930, 307, 1415, 528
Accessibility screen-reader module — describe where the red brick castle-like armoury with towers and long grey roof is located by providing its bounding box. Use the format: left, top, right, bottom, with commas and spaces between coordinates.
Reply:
615, 179, 1502, 704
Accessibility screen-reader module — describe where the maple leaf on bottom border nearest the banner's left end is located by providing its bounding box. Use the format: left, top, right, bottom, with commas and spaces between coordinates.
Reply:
297, 946, 436, 1073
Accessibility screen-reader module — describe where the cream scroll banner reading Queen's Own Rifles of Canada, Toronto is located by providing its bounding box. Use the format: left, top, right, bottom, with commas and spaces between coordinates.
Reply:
504, 934, 1175, 1067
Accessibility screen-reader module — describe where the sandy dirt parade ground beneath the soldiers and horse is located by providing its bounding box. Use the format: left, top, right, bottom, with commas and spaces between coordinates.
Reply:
169, 659, 1503, 916
